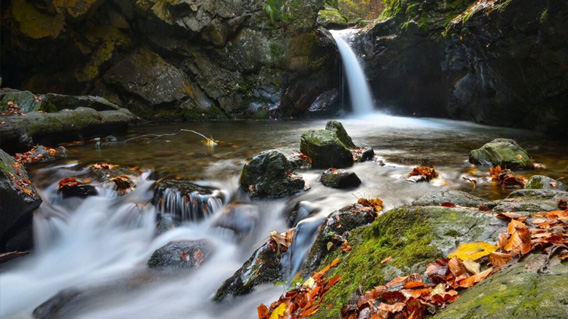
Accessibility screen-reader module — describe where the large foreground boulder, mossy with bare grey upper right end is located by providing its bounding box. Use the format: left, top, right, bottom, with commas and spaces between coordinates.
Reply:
308, 206, 507, 319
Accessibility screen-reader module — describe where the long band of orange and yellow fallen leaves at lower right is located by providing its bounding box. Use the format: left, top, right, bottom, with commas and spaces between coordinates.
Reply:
341, 210, 568, 319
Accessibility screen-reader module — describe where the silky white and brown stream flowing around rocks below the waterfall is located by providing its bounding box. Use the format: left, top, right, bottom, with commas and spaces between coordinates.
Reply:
0, 113, 568, 319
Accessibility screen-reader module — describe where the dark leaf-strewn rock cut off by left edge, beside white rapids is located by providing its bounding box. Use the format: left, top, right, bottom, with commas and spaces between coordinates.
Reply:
0, 150, 41, 253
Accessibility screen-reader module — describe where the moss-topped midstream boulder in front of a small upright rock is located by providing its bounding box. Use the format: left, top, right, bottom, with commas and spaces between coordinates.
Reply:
300, 130, 353, 168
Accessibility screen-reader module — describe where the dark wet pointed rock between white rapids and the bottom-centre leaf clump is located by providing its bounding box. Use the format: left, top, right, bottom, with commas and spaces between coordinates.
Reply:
213, 243, 286, 302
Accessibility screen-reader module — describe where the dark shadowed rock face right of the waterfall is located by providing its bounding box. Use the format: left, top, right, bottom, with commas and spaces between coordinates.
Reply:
358, 0, 568, 136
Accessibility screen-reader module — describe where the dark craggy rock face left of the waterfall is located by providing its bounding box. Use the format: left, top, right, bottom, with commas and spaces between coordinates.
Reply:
1, 0, 337, 120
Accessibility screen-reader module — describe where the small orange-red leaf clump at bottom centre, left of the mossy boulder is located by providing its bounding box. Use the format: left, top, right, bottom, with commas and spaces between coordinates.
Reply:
257, 258, 341, 319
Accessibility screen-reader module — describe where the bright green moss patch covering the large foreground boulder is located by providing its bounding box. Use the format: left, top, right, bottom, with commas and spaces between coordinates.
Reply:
314, 208, 441, 318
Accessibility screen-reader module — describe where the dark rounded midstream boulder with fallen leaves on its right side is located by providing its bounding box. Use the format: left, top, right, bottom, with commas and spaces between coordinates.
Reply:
240, 150, 304, 198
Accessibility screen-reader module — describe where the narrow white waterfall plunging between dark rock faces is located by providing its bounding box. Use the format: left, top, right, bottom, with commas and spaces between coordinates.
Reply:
330, 29, 373, 115
